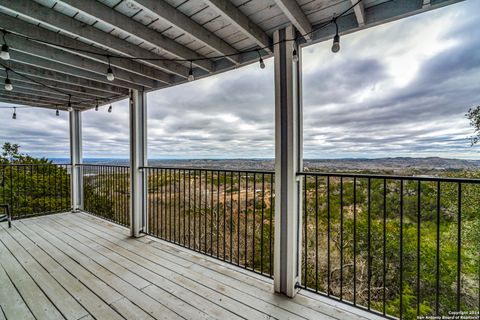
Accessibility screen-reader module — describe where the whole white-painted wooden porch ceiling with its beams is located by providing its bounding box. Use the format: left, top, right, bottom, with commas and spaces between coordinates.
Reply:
0, 0, 461, 110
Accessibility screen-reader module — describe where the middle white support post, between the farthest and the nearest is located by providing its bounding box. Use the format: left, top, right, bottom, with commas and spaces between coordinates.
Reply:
129, 90, 148, 237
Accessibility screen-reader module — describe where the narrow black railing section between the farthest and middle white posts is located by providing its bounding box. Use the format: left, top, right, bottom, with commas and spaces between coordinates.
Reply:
81, 164, 130, 227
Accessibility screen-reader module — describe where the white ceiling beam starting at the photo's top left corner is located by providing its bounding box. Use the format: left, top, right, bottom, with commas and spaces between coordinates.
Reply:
0, 0, 193, 78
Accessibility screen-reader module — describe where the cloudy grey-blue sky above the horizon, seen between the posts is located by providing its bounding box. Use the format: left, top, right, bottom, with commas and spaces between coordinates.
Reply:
0, 0, 480, 159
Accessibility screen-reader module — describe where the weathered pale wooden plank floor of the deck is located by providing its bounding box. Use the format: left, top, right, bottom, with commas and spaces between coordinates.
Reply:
0, 213, 382, 320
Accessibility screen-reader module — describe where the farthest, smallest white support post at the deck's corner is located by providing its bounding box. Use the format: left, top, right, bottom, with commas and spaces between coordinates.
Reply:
70, 110, 83, 212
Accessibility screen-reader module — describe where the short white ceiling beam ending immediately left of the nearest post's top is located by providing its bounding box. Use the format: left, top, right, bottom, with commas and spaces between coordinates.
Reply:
203, 0, 272, 52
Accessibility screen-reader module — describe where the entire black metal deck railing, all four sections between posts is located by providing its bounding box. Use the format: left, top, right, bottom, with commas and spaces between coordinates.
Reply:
0, 164, 480, 319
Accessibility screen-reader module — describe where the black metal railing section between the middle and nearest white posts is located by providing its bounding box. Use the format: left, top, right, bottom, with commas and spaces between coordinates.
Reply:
144, 167, 275, 277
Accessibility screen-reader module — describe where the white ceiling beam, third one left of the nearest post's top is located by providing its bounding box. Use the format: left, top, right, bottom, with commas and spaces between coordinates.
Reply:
55, 0, 214, 72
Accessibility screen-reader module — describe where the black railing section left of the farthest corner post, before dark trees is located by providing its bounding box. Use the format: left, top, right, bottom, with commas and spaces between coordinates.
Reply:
0, 163, 71, 219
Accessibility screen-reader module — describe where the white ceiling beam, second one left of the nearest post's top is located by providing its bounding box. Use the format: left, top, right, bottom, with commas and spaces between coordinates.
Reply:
131, 0, 241, 64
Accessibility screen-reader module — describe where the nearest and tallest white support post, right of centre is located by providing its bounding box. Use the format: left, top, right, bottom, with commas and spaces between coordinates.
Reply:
273, 26, 303, 297
